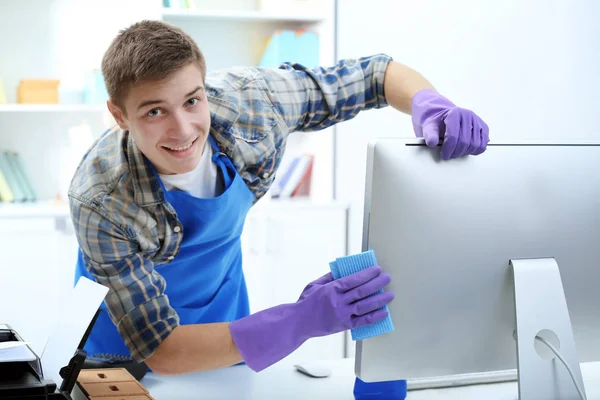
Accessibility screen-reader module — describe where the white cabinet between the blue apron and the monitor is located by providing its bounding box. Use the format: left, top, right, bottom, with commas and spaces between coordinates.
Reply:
242, 200, 347, 362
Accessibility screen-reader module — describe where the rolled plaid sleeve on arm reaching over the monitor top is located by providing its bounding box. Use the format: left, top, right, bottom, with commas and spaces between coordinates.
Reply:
259, 54, 392, 132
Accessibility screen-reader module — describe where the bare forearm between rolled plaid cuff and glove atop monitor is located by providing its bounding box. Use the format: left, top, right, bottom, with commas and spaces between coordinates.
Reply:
383, 61, 434, 114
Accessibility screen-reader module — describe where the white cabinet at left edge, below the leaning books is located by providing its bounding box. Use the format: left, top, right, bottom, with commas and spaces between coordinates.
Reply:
0, 206, 77, 354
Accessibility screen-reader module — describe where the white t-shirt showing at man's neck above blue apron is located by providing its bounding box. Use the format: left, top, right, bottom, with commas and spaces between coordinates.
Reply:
159, 140, 218, 198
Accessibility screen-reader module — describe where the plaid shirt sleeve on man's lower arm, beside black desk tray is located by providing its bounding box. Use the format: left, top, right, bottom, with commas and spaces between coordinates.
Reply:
71, 199, 179, 362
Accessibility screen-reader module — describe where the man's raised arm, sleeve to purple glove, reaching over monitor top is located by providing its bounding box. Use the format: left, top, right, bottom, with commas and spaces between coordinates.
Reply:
261, 54, 489, 159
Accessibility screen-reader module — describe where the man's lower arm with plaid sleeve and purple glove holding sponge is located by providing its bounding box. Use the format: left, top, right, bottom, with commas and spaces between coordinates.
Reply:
72, 200, 393, 375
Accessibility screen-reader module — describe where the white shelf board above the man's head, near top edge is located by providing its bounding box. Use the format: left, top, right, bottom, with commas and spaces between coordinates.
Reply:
162, 8, 325, 23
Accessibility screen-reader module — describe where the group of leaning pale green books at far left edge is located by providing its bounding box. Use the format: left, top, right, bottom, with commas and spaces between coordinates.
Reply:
0, 150, 38, 203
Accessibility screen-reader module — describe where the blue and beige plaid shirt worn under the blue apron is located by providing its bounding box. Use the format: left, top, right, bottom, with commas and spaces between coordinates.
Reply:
69, 51, 391, 361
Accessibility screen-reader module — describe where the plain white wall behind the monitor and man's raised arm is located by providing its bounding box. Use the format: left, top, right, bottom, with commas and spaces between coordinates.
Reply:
336, 0, 600, 253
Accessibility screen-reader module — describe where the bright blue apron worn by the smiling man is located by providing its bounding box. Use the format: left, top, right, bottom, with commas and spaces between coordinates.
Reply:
75, 136, 254, 356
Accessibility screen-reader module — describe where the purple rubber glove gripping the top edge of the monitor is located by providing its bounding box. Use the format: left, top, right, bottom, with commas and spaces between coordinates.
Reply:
412, 89, 490, 160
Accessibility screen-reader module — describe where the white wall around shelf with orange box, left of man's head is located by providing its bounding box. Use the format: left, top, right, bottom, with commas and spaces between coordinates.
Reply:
0, 0, 162, 200
